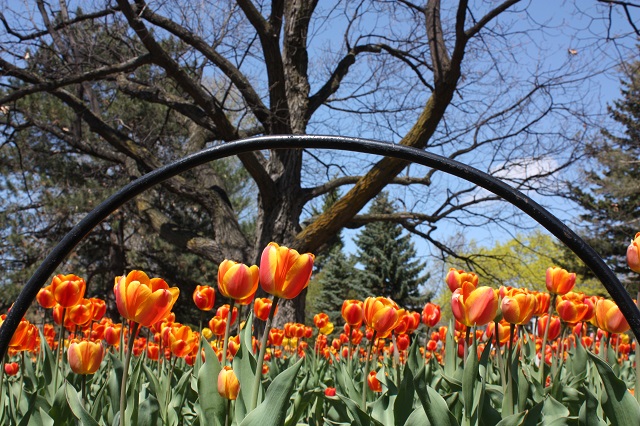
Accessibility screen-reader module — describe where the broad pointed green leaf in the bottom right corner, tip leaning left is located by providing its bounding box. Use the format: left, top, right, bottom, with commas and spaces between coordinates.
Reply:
588, 352, 640, 425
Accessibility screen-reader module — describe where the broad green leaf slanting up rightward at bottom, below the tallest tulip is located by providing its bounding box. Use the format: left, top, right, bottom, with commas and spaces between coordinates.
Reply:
241, 359, 304, 426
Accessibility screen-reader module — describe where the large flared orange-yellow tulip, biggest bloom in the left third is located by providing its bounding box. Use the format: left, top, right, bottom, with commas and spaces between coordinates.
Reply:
113, 271, 180, 327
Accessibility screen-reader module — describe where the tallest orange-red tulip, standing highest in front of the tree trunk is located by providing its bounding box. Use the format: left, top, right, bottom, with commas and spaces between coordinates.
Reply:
260, 243, 315, 299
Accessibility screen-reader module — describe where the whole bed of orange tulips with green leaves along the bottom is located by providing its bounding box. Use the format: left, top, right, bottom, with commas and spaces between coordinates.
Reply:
0, 238, 640, 426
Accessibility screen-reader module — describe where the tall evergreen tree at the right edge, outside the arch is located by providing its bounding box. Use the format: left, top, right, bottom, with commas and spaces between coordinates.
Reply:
570, 63, 640, 286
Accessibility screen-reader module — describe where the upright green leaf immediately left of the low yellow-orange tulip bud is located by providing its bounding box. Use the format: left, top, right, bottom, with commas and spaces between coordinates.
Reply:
198, 336, 227, 425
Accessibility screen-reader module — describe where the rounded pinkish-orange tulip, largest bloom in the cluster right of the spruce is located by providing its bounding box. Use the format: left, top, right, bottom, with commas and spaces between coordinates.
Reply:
451, 281, 498, 327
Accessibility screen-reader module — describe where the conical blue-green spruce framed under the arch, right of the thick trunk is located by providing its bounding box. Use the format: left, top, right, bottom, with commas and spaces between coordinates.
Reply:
356, 192, 428, 310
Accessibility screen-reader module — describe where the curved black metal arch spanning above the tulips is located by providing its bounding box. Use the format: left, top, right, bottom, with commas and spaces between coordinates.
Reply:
0, 135, 640, 359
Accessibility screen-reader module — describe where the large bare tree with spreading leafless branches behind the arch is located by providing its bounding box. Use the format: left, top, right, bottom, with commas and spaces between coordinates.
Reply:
0, 0, 632, 320
